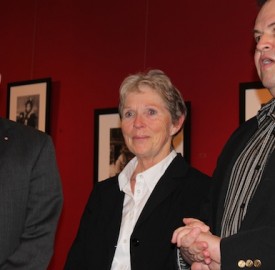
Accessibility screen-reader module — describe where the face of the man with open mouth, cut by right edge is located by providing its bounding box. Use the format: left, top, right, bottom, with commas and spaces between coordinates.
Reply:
254, 0, 275, 96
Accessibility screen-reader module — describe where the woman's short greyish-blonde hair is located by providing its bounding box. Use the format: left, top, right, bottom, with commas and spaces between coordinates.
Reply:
118, 70, 187, 124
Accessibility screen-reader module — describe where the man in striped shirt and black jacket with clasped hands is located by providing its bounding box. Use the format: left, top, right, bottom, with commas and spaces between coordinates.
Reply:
172, 0, 275, 270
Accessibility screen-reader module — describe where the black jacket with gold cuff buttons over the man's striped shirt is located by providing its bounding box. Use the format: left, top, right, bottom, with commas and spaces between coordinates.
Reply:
212, 117, 275, 270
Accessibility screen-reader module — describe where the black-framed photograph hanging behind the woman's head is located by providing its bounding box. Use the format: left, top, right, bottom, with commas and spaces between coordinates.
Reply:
94, 102, 191, 182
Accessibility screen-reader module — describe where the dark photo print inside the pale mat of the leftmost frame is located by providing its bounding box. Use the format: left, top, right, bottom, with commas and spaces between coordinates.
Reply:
16, 95, 39, 129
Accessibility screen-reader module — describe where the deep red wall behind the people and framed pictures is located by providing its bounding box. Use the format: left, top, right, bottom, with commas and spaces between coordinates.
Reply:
0, 0, 258, 270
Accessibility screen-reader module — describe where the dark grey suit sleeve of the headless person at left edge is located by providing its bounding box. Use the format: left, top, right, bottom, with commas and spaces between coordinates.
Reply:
0, 136, 63, 270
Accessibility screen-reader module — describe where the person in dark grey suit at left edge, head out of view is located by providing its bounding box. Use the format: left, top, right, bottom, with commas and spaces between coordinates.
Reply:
0, 118, 63, 270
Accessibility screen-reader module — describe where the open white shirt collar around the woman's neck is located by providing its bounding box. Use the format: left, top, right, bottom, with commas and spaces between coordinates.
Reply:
118, 150, 177, 191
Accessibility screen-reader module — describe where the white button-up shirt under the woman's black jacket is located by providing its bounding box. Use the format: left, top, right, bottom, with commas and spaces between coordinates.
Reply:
111, 150, 177, 270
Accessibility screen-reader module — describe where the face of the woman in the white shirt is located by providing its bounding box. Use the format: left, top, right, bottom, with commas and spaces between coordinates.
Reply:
121, 86, 181, 164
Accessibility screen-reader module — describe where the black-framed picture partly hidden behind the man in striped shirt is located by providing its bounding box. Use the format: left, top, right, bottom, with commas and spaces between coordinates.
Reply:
239, 82, 272, 124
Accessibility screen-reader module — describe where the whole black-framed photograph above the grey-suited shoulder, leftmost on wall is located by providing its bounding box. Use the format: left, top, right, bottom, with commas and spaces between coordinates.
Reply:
7, 78, 51, 133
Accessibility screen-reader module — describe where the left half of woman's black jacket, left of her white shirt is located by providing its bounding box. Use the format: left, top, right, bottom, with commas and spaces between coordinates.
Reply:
64, 176, 124, 270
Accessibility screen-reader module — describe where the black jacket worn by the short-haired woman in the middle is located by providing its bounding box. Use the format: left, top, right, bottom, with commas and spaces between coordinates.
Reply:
65, 155, 210, 270
